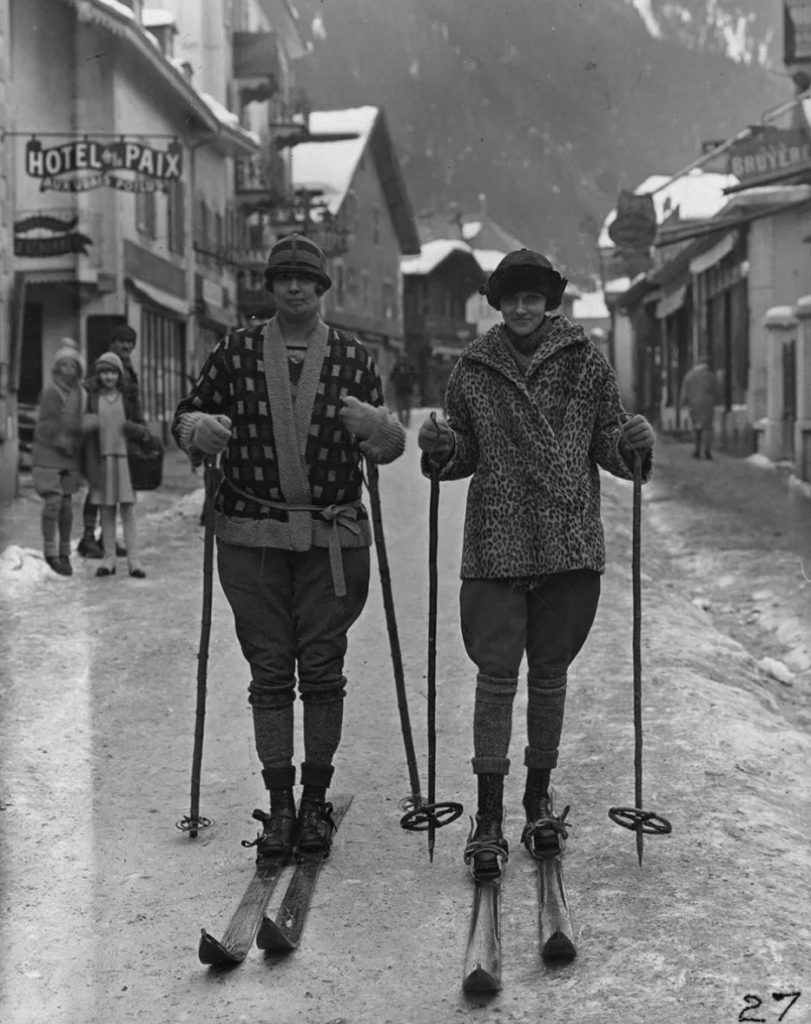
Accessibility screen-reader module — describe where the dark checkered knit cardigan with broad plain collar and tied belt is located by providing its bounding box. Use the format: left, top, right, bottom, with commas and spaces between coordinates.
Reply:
172, 318, 406, 551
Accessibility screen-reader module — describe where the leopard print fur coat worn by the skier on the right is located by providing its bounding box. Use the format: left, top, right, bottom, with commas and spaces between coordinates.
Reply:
430, 314, 651, 581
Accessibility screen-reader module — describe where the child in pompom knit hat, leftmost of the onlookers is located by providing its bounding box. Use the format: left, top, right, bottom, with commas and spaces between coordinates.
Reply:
31, 338, 85, 575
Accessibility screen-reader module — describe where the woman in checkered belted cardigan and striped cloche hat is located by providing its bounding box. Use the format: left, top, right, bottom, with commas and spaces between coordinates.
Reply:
172, 234, 406, 859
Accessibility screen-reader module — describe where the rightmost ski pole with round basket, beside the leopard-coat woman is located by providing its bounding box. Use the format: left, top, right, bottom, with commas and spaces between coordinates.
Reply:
608, 452, 672, 867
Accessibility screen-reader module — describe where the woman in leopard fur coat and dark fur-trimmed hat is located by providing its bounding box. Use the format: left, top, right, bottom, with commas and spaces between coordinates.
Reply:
418, 249, 654, 881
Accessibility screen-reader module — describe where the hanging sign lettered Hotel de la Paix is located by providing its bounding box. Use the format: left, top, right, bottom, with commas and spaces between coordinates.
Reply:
26, 135, 183, 193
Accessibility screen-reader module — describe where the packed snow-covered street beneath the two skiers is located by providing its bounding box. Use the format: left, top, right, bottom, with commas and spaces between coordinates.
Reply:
0, 425, 811, 1024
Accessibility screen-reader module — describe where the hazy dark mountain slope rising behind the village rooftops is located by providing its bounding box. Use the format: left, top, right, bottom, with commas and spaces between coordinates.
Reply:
297, 0, 792, 280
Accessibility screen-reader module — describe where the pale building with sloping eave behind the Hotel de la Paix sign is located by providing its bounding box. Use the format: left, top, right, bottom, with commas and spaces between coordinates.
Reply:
2, 0, 258, 495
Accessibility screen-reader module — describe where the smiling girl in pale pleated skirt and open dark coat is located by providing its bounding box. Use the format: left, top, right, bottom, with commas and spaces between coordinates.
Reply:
83, 352, 150, 580
